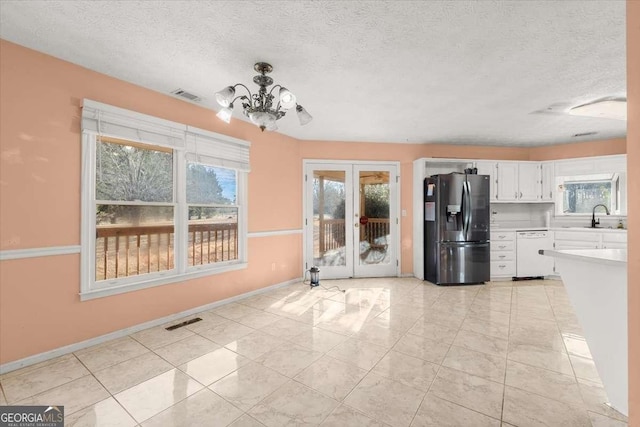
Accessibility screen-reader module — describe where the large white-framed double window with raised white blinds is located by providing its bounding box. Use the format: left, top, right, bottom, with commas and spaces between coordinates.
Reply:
81, 100, 250, 299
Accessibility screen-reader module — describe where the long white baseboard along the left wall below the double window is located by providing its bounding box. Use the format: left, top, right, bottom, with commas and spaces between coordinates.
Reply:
0, 277, 302, 375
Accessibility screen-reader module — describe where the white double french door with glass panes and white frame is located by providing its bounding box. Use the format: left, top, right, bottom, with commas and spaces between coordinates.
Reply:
304, 161, 399, 279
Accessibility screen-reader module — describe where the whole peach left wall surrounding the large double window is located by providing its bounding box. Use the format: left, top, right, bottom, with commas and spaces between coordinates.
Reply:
0, 40, 302, 364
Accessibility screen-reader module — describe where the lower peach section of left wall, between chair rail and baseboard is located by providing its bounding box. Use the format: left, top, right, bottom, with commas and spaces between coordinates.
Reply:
0, 234, 302, 363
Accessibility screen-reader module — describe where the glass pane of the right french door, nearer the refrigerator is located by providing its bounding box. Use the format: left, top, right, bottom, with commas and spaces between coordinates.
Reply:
356, 171, 390, 265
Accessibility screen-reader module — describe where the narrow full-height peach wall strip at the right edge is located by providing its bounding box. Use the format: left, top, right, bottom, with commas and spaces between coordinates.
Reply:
627, 0, 640, 427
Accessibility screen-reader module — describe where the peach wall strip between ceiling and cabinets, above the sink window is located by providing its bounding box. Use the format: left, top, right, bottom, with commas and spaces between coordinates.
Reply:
529, 138, 627, 161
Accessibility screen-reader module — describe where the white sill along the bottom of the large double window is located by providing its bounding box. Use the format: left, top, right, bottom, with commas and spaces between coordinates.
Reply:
80, 262, 248, 301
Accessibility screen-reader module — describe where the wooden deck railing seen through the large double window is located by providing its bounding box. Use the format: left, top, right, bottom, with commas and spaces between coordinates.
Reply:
96, 222, 238, 280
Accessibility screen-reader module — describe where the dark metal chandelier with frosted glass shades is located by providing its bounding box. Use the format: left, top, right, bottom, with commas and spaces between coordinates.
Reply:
216, 62, 313, 132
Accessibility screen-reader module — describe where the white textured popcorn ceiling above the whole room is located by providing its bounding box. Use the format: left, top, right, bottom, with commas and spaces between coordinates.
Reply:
0, 0, 626, 146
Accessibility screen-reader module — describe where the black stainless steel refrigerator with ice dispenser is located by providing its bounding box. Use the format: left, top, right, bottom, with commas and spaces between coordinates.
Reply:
424, 173, 491, 285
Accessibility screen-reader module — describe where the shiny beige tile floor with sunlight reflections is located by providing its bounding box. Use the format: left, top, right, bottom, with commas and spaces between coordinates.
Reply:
0, 278, 627, 427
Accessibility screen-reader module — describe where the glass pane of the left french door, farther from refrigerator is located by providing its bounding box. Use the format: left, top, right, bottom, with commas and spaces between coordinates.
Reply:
313, 170, 346, 267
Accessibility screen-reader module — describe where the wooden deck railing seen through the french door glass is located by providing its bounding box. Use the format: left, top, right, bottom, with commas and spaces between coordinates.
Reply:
318, 218, 389, 254
